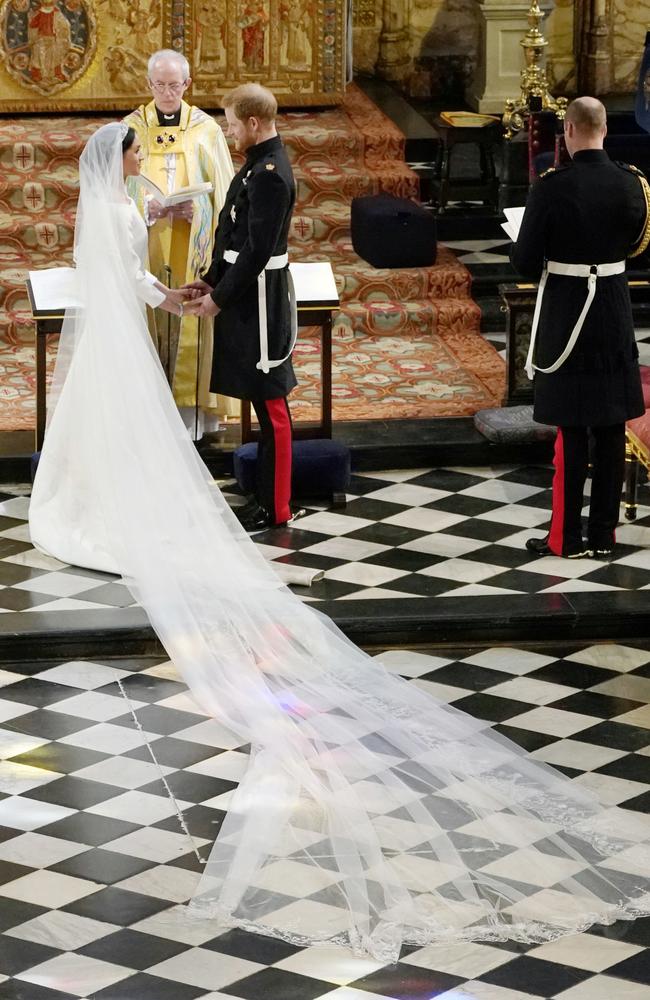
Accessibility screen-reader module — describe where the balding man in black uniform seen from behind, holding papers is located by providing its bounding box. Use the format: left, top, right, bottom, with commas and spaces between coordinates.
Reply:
512, 97, 650, 558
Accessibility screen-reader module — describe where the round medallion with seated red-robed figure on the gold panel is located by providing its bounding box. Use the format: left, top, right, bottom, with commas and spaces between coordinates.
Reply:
0, 0, 97, 95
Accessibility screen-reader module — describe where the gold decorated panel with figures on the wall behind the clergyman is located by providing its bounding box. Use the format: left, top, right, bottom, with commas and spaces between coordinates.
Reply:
0, 0, 346, 112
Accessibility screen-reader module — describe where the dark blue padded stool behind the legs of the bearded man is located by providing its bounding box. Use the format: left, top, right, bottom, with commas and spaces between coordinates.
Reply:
233, 438, 351, 507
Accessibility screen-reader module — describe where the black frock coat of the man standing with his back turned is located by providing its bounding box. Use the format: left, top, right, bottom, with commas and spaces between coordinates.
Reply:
511, 149, 647, 427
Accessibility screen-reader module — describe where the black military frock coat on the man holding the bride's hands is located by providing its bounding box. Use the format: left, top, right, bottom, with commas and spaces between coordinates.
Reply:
203, 137, 296, 400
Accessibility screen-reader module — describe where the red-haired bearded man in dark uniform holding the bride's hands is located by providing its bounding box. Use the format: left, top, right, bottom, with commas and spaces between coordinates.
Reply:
185, 83, 296, 531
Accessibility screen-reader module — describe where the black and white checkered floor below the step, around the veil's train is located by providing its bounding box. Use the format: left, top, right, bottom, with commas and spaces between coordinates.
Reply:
0, 640, 650, 1000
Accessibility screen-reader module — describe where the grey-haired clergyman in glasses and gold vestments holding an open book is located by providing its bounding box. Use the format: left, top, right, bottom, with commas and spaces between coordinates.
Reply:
124, 50, 234, 437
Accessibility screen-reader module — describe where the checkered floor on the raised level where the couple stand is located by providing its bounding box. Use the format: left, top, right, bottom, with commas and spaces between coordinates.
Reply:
0, 466, 650, 614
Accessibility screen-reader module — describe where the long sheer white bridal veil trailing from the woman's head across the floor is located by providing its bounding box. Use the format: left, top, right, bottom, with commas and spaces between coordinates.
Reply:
30, 125, 650, 961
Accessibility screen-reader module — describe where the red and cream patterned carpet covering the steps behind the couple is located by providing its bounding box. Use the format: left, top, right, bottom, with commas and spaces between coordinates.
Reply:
0, 86, 504, 430
